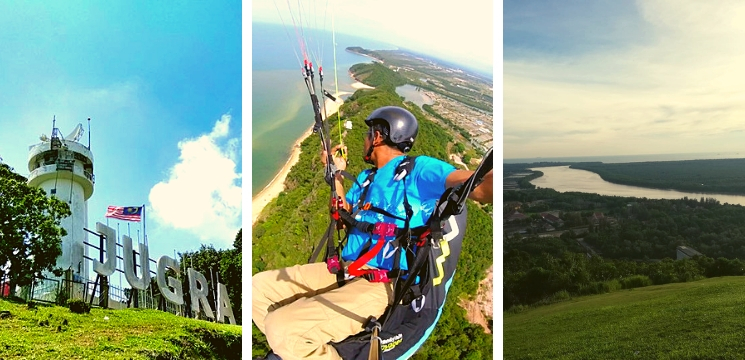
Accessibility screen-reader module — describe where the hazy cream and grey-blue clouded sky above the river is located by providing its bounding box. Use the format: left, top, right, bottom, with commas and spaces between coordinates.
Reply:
504, 0, 745, 158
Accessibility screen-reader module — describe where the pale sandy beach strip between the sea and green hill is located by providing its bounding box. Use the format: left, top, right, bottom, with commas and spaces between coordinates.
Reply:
251, 93, 344, 225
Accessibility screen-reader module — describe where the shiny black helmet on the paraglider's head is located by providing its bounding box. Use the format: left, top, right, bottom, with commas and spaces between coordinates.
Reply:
365, 106, 419, 152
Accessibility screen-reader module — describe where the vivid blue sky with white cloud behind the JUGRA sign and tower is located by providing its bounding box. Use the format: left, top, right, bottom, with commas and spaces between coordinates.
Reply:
0, 1, 243, 258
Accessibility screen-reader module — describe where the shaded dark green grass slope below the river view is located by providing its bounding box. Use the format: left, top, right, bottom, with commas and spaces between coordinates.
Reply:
503, 277, 745, 359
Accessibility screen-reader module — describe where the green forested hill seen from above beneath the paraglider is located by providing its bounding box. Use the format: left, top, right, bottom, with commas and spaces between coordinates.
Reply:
252, 64, 493, 359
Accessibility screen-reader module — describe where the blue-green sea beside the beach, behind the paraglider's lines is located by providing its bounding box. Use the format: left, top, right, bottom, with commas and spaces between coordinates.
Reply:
251, 23, 396, 196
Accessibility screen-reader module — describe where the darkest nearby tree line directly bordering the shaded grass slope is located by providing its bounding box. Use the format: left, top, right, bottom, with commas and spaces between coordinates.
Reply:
503, 243, 745, 311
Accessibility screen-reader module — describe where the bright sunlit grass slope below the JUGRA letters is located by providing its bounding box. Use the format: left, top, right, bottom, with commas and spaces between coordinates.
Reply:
0, 300, 241, 359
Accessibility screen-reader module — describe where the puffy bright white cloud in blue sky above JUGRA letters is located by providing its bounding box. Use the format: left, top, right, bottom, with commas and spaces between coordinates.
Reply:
149, 114, 241, 247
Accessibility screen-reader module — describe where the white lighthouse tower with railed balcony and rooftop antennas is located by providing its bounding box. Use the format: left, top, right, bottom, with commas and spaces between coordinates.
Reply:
28, 119, 95, 280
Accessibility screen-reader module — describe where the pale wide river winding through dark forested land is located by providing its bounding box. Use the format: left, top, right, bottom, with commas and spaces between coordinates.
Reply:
530, 166, 745, 205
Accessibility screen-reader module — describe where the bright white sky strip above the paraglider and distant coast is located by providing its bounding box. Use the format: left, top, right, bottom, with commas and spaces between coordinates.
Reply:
251, 0, 499, 71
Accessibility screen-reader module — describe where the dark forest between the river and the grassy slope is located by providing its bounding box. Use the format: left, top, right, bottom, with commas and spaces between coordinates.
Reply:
503, 184, 745, 310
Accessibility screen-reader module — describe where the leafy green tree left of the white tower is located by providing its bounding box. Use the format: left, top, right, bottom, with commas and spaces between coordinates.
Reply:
0, 163, 71, 289
